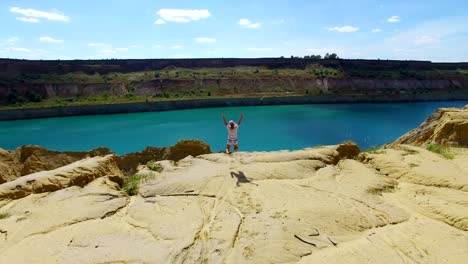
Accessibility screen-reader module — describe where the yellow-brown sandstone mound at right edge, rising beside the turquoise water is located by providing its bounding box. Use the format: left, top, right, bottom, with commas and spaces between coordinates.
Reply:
393, 105, 468, 147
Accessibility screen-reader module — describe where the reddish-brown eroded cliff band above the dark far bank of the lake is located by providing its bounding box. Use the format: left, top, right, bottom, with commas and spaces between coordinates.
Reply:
0, 78, 468, 102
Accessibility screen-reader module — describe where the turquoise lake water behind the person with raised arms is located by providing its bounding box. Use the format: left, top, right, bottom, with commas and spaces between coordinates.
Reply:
0, 101, 468, 154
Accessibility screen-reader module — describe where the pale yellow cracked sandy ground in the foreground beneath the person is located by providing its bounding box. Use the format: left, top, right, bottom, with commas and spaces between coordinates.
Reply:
0, 108, 468, 263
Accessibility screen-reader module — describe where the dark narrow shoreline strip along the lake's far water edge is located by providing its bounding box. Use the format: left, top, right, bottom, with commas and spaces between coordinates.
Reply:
0, 91, 468, 121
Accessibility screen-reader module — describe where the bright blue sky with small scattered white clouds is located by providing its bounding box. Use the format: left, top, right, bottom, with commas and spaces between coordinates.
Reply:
0, 0, 468, 61
